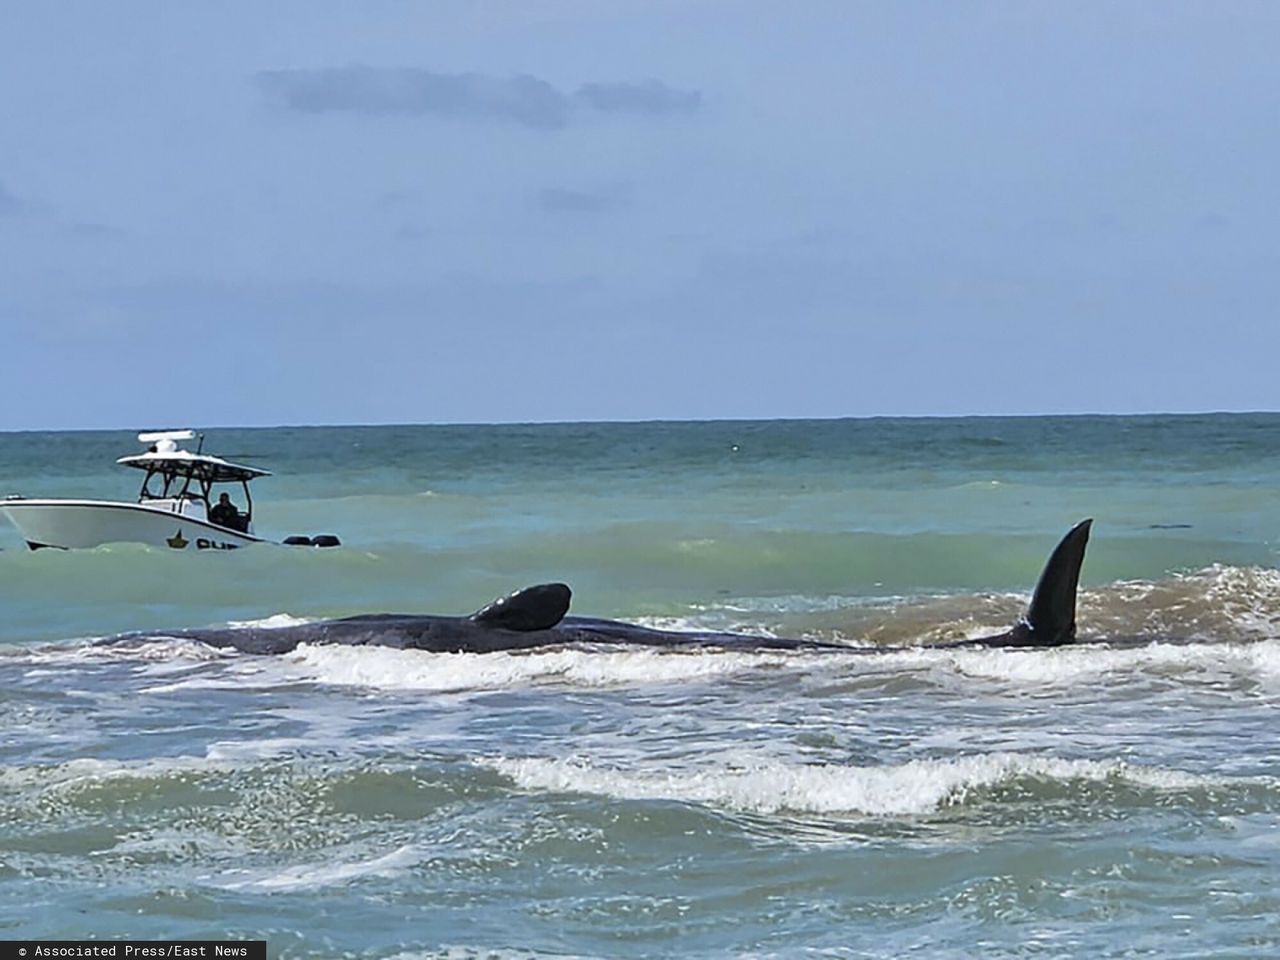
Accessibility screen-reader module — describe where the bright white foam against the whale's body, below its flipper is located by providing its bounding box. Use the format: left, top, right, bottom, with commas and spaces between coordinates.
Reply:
288, 644, 787, 691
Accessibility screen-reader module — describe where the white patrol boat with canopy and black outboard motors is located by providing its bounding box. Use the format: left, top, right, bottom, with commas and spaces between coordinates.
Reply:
0, 430, 338, 550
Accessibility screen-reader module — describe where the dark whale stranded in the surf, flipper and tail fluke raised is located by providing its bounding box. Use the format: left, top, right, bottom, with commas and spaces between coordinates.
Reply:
114, 520, 1093, 655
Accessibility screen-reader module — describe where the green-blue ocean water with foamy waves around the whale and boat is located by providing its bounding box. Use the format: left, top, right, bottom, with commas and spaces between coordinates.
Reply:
0, 415, 1280, 957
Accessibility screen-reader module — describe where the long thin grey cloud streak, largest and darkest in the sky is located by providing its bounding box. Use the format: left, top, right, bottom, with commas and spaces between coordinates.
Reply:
253, 65, 701, 131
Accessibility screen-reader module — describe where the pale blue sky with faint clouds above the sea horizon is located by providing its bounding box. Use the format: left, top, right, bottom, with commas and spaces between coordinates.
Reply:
0, 0, 1280, 430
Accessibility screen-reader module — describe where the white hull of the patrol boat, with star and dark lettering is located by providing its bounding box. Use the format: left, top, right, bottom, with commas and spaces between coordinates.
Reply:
0, 499, 262, 550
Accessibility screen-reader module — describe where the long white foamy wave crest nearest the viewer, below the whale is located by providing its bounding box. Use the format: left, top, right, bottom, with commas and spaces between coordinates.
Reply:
477, 753, 1217, 817
